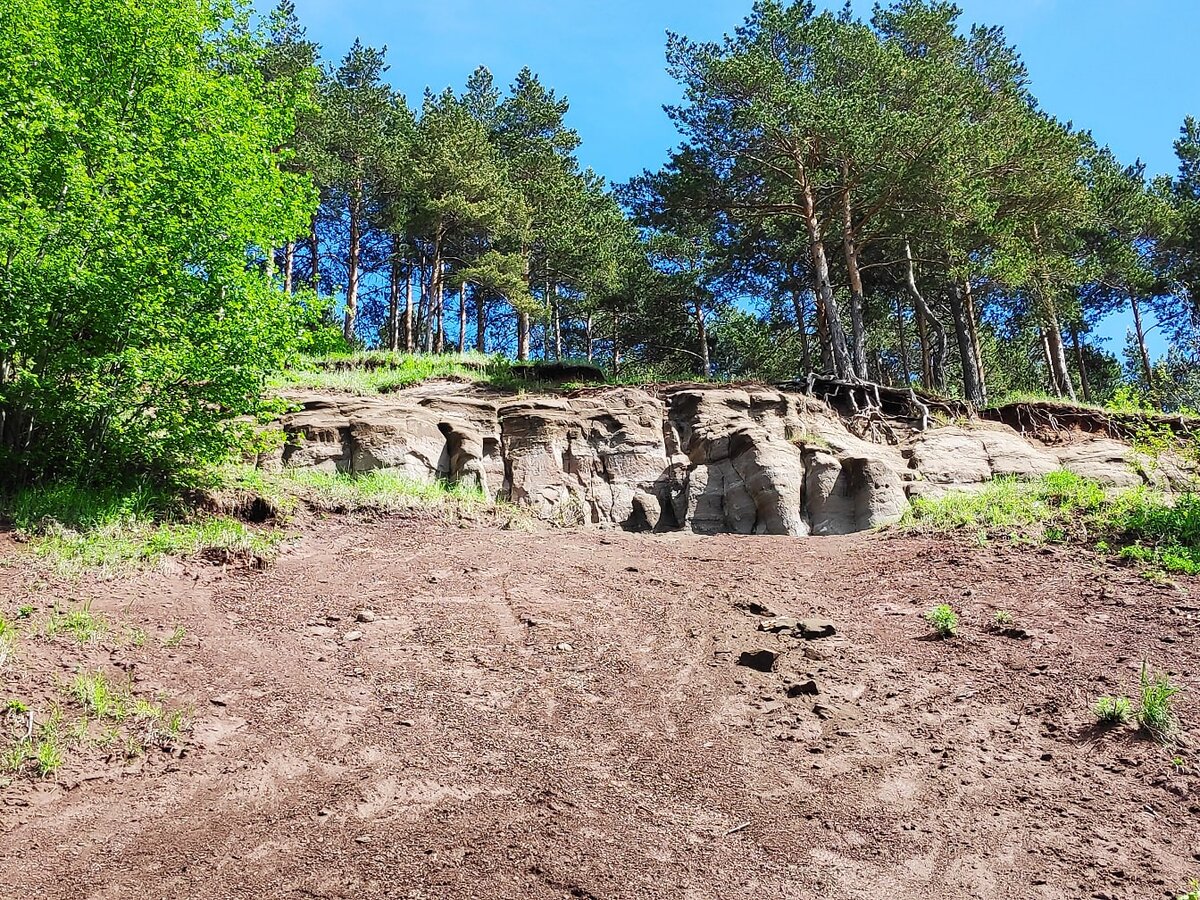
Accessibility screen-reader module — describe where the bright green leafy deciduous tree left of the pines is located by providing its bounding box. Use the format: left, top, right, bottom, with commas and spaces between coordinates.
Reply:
0, 0, 316, 481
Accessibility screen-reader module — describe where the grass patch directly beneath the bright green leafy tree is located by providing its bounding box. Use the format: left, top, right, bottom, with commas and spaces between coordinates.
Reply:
0, 482, 282, 574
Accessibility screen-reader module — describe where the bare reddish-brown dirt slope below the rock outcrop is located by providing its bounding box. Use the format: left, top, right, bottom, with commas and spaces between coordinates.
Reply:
0, 520, 1200, 900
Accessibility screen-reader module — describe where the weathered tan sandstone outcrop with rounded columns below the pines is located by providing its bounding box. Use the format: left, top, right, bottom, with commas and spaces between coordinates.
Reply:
270, 384, 1140, 535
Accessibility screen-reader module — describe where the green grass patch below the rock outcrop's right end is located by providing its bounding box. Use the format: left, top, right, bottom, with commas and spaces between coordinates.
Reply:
901, 472, 1200, 575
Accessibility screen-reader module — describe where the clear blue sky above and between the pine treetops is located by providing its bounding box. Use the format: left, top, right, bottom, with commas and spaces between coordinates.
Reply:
283, 0, 1200, 360
